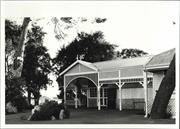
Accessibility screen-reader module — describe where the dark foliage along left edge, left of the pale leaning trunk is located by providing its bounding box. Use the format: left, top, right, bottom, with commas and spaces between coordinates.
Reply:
5, 20, 28, 111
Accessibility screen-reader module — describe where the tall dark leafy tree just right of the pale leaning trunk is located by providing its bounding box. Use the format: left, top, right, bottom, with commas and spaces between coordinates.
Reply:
23, 25, 51, 105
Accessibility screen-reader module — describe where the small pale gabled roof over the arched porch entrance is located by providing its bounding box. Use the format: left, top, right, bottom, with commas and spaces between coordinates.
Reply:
59, 60, 97, 76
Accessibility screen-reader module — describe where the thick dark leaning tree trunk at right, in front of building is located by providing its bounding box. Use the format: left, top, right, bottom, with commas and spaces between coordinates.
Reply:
150, 56, 175, 119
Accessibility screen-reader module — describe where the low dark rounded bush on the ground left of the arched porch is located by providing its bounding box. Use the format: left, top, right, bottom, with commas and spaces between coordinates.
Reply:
30, 101, 70, 121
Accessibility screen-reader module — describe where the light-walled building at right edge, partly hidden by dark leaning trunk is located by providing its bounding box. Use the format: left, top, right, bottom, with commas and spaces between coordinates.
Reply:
145, 49, 175, 117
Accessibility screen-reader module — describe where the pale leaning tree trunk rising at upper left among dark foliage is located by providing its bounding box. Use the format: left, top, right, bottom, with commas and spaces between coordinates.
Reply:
12, 17, 31, 78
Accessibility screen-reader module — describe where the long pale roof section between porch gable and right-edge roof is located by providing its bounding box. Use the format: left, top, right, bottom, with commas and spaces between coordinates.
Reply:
93, 56, 152, 70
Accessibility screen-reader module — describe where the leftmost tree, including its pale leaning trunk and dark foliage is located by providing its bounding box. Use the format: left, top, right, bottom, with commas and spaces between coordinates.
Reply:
5, 18, 28, 111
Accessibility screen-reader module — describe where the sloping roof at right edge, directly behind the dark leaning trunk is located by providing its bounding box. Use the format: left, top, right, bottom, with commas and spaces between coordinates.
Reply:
145, 48, 175, 71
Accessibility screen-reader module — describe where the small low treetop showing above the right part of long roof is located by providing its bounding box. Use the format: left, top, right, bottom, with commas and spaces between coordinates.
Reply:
117, 48, 147, 59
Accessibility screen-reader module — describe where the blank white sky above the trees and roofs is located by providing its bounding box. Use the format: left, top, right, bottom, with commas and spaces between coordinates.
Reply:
4, 1, 180, 96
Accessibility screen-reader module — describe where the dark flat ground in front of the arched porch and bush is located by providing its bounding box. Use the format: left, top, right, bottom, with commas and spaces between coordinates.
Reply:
6, 109, 175, 124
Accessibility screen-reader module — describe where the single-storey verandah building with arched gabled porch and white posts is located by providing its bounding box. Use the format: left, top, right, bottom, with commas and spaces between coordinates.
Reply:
60, 47, 175, 116
